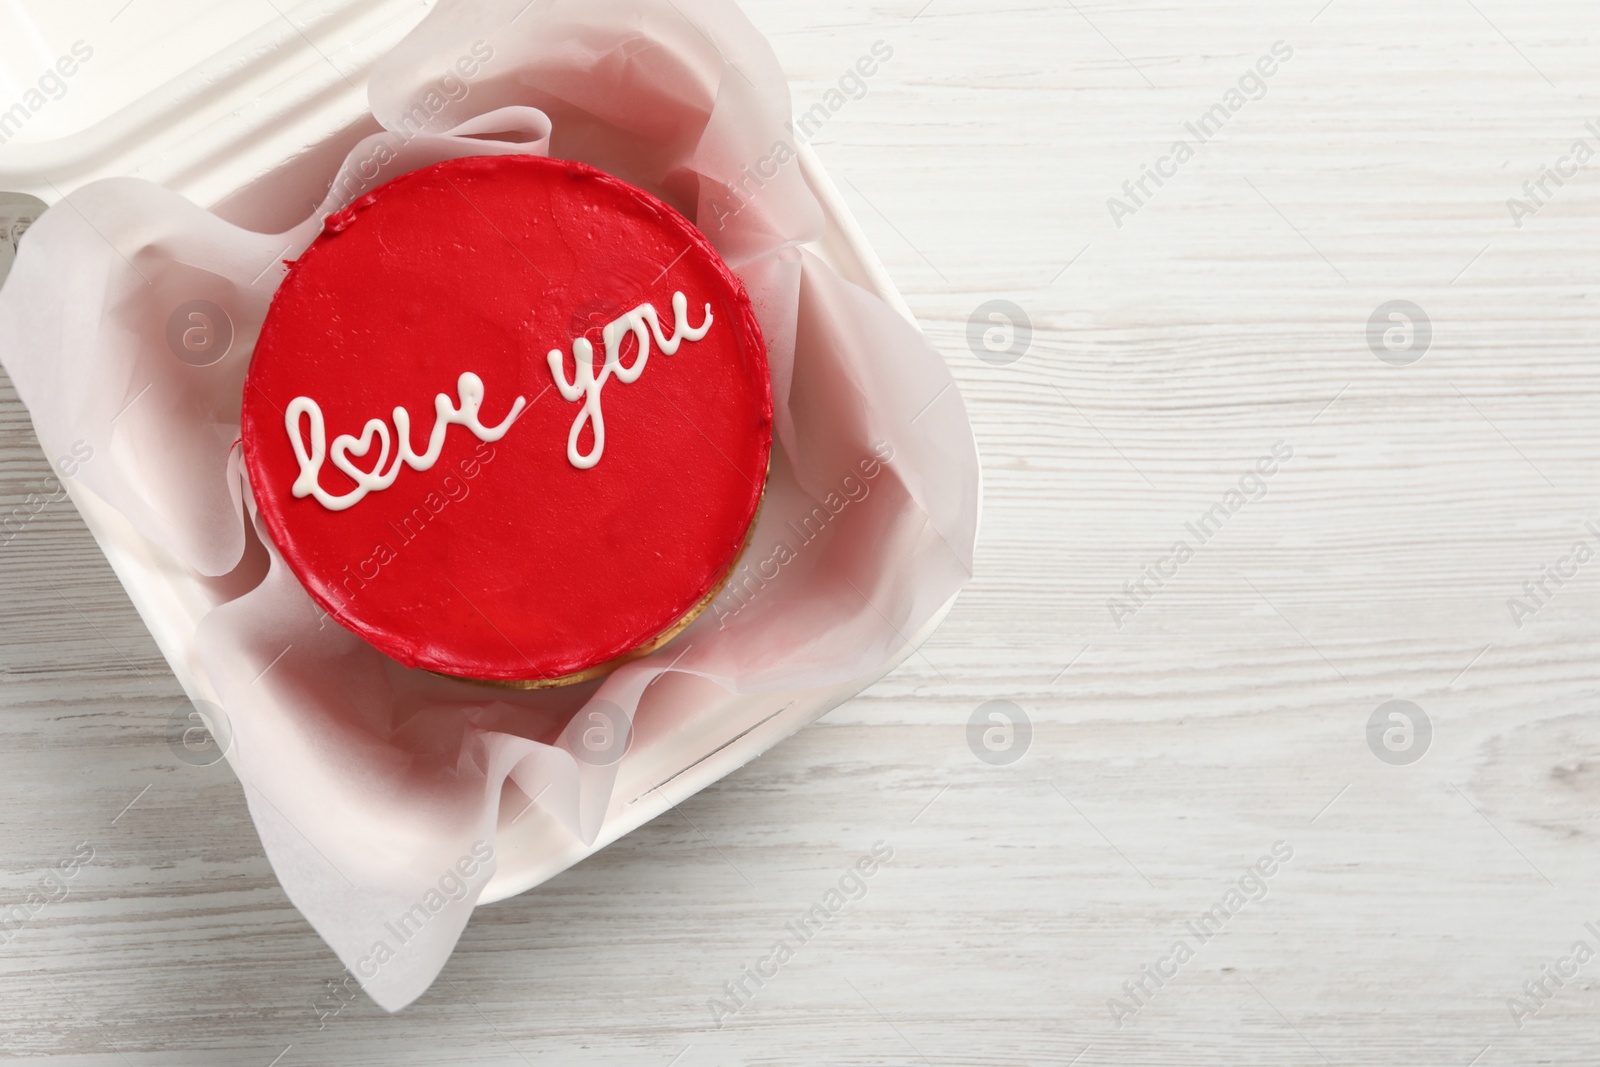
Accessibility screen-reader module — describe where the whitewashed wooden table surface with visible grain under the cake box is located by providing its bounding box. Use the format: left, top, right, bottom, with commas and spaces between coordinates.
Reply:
0, 0, 1600, 1067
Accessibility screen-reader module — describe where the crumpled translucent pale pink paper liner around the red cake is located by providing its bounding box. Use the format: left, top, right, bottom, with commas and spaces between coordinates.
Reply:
0, 0, 979, 1011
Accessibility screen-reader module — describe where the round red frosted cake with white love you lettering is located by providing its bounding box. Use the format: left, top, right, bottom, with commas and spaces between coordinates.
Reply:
243, 155, 773, 685
